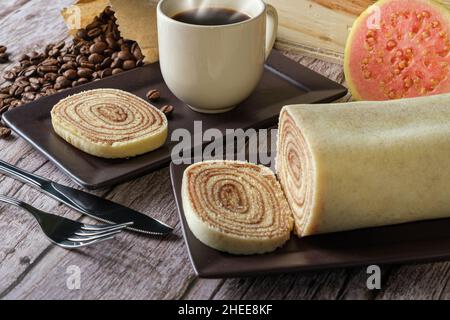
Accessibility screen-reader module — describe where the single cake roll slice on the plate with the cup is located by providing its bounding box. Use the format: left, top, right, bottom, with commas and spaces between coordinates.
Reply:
51, 89, 167, 158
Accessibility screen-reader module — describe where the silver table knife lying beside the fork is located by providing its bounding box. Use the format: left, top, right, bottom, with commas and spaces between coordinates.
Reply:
0, 160, 173, 235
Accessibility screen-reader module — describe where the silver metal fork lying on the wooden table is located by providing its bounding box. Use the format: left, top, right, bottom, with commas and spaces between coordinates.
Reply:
0, 195, 133, 249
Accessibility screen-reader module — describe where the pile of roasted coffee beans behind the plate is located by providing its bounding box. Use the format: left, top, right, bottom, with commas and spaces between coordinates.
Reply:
0, 8, 144, 122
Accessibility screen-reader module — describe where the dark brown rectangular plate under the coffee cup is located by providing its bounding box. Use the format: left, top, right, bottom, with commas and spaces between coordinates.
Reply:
3, 51, 347, 189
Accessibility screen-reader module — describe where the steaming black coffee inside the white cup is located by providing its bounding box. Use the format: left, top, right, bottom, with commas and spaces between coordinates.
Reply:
172, 8, 250, 26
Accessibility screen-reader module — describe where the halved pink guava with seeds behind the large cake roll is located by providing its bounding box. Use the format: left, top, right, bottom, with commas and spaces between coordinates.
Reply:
344, 0, 450, 100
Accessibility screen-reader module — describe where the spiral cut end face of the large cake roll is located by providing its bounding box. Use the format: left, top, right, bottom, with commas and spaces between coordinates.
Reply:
276, 111, 314, 235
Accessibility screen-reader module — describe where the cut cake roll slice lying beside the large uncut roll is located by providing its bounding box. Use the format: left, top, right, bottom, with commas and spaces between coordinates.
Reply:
182, 161, 293, 254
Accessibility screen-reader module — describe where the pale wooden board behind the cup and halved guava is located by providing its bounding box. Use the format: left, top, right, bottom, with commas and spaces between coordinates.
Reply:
267, 0, 450, 64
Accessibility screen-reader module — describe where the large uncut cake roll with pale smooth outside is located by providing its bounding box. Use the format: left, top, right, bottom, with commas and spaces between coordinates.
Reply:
276, 94, 450, 236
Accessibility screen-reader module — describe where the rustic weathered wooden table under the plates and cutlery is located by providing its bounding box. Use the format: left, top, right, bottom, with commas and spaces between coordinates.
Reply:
0, 0, 450, 299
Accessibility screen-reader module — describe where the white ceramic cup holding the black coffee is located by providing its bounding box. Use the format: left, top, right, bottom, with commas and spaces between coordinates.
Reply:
157, 0, 278, 113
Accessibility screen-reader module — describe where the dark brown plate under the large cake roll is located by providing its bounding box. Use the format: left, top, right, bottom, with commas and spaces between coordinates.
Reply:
170, 163, 450, 278
